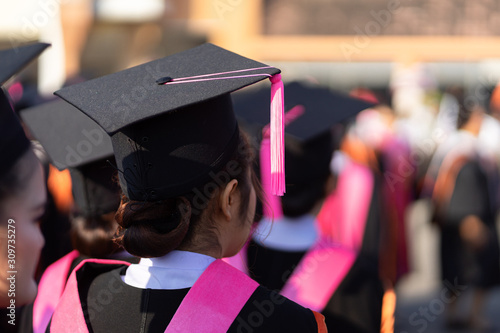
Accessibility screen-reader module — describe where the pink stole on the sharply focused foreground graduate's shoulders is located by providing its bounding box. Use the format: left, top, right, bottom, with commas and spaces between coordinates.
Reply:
50, 259, 259, 333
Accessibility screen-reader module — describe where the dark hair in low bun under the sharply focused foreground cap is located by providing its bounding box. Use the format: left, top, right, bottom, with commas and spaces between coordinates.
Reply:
115, 131, 255, 258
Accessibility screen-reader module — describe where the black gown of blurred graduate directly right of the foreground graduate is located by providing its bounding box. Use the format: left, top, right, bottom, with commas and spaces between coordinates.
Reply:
248, 175, 384, 333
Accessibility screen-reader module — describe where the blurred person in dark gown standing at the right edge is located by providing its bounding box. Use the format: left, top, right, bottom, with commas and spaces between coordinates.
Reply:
428, 90, 500, 330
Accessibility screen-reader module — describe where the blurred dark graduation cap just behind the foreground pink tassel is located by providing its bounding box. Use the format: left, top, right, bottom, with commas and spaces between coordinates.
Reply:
233, 82, 373, 217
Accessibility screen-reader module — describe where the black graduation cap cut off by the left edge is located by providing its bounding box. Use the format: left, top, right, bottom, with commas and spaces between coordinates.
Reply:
0, 43, 49, 177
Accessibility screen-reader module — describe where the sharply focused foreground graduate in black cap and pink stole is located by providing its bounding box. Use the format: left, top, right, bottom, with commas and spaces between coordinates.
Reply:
49, 44, 326, 332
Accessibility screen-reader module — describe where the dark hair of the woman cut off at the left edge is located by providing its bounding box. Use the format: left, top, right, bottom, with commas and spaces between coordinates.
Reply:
0, 148, 37, 213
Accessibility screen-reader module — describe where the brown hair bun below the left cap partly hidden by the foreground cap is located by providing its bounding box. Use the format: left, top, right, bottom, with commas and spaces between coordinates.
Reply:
70, 212, 120, 258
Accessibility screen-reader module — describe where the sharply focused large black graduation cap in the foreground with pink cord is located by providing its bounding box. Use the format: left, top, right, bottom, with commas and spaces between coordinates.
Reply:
56, 44, 282, 201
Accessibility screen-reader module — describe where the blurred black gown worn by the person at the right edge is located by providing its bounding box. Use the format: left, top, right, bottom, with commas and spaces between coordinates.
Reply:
438, 160, 500, 288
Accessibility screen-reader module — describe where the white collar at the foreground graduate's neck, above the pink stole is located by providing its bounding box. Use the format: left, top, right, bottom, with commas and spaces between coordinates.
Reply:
122, 250, 215, 289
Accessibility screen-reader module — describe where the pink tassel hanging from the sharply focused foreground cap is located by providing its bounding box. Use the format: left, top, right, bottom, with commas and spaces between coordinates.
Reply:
269, 74, 286, 196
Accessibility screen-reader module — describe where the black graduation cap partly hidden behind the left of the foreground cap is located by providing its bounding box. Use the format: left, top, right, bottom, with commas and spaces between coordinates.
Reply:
20, 100, 120, 217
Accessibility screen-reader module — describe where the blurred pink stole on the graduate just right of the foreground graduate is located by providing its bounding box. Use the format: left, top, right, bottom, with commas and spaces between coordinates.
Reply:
281, 162, 374, 311
